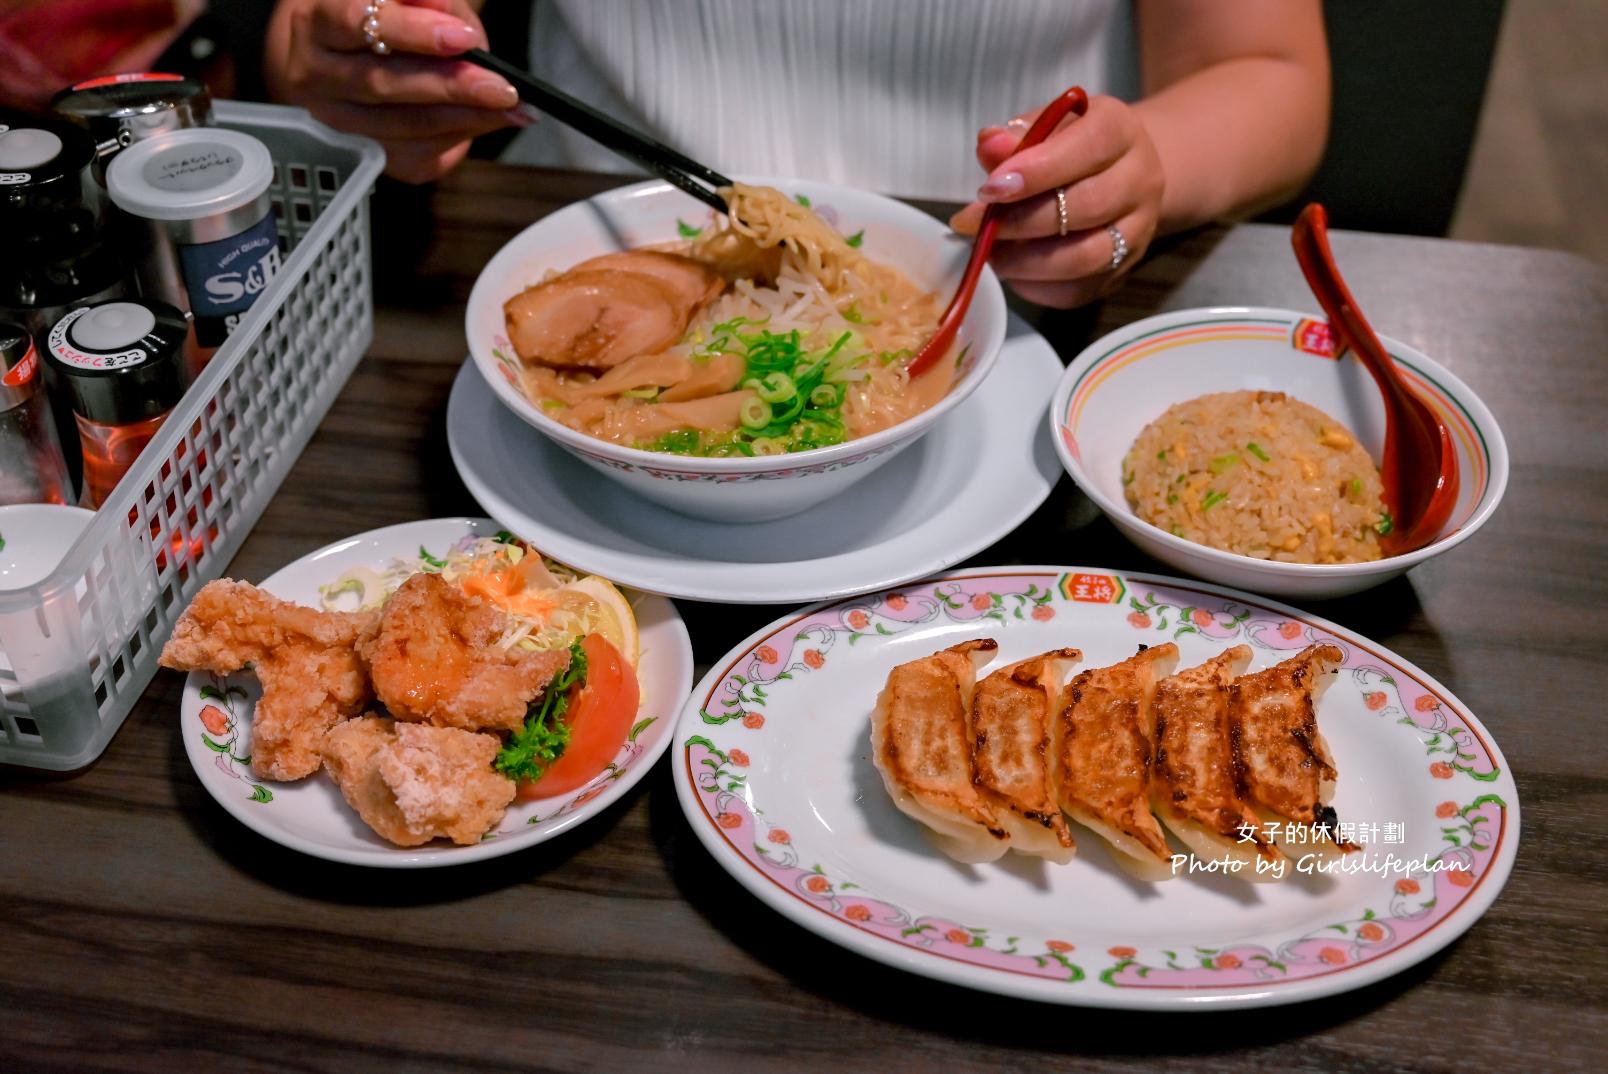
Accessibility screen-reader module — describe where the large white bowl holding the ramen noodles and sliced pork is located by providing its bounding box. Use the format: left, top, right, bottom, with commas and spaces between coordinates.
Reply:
465, 178, 1005, 523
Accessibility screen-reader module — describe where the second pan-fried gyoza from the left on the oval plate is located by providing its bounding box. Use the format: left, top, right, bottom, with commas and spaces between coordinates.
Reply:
971, 650, 1082, 865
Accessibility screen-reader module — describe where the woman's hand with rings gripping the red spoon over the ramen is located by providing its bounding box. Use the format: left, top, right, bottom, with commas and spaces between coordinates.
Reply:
950, 96, 1166, 307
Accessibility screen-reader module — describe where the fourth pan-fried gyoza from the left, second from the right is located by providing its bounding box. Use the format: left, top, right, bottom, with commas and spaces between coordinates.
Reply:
1150, 645, 1283, 881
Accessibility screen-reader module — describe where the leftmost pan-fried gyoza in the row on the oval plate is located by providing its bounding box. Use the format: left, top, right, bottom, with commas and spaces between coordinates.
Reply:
872, 638, 1010, 863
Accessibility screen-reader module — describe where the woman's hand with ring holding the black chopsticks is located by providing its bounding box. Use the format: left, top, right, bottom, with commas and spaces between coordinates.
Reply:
264, 0, 527, 183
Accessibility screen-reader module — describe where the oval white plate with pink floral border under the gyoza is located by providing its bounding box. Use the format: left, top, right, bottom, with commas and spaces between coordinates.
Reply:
672, 568, 1520, 1010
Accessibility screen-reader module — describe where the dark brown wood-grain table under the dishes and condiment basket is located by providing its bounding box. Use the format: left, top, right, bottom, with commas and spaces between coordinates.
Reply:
0, 164, 1608, 1074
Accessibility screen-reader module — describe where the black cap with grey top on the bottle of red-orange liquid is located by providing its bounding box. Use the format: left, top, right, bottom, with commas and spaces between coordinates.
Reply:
45, 299, 190, 424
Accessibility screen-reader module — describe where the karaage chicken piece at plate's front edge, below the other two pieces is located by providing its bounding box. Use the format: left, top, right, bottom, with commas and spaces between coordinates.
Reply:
323, 715, 515, 847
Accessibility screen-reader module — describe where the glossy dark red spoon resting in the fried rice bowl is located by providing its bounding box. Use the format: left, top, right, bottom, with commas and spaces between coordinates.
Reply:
1290, 203, 1457, 556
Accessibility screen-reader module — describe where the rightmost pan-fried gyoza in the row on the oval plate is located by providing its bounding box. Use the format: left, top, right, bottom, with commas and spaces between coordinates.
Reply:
1229, 645, 1356, 852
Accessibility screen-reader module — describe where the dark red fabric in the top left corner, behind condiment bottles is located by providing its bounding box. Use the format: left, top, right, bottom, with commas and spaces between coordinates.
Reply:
0, 0, 204, 111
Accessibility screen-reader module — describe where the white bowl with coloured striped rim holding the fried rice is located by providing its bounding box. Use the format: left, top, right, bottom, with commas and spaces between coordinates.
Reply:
1050, 307, 1508, 598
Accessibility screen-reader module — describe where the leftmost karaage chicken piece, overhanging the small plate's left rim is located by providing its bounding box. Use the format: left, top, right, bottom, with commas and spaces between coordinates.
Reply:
161, 579, 375, 780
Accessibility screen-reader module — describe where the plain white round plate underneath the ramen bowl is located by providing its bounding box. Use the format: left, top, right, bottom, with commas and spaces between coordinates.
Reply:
447, 317, 1061, 605
